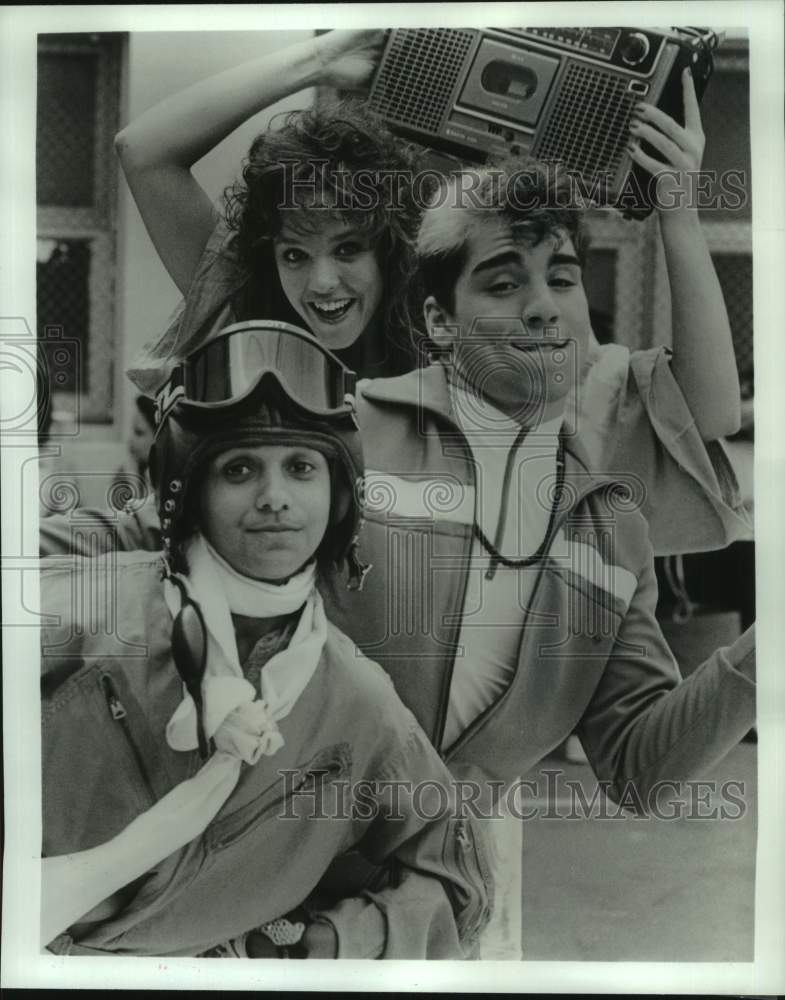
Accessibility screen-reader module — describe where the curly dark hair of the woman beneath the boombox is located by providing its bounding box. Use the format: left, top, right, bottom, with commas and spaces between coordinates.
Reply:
224, 101, 420, 354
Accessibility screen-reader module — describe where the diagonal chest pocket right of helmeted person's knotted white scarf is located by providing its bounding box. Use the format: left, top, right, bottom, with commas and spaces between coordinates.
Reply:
206, 743, 352, 852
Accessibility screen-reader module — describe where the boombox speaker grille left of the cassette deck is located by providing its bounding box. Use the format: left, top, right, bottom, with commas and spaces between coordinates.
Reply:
369, 28, 475, 132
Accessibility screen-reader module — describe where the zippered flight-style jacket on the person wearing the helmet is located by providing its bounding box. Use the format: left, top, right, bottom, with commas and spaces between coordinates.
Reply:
41, 553, 492, 959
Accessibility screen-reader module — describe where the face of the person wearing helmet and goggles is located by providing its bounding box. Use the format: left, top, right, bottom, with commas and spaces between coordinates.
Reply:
200, 445, 330, 580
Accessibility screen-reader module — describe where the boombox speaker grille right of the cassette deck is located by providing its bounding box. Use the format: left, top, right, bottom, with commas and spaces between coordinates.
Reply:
532, 63, 640, 180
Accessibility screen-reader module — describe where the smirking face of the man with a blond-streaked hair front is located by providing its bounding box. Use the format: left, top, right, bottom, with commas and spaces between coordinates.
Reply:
425, 212, 591, 426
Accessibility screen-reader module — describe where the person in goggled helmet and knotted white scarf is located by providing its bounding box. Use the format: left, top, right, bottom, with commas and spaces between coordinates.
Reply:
41, 322, 491, 958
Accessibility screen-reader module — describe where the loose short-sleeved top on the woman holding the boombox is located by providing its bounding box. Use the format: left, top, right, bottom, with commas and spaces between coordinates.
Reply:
121, 219, 752, 555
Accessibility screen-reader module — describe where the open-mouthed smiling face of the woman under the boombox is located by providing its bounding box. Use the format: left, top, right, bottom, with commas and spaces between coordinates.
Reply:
273, 208, 384, 350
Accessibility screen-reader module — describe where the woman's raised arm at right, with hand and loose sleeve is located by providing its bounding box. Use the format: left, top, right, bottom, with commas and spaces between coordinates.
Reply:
580, 73, 752, 555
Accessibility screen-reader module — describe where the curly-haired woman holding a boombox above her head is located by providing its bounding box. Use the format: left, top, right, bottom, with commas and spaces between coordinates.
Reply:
112, 29, 752, 555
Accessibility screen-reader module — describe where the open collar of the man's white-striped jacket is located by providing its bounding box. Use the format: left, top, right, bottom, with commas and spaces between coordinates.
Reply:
357, 362, 616, 497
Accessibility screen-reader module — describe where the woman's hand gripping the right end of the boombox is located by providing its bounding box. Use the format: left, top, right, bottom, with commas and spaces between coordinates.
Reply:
627, 69, 706, 222
